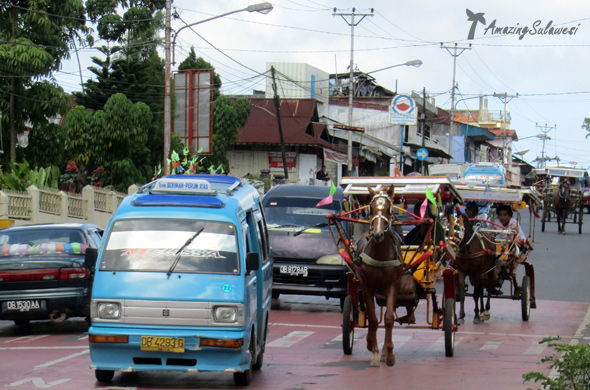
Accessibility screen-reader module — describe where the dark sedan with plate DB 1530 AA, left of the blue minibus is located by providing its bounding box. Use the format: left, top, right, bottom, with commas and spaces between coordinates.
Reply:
0, 223, 102, 325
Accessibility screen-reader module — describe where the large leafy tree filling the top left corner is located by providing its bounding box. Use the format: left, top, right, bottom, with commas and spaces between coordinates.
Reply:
0, 0, 92, 161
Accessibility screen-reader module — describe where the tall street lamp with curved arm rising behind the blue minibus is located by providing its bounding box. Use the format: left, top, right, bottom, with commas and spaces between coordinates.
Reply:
162, 0, 273, 174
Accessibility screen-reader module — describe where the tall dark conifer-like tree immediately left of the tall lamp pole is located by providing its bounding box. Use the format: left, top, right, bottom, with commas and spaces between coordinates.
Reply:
75, 0, 165, 180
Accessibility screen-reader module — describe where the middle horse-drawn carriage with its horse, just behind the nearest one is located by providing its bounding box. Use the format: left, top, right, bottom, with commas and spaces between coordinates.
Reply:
452, 184, 541, 323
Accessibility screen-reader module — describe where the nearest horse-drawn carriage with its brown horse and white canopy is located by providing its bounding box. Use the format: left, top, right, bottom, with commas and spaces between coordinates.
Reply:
329, 177, 463, 366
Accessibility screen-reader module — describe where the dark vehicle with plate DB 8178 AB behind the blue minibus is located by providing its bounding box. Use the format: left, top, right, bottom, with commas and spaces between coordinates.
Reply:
262, 184, 349, 303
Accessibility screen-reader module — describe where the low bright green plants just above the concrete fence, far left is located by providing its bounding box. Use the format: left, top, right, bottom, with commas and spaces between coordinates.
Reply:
0, 160, 59, 191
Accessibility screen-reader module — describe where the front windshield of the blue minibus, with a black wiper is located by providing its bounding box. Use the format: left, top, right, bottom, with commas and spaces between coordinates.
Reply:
99, 219, 240, 274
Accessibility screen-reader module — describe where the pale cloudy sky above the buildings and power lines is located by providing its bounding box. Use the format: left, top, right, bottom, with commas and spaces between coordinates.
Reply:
55, 0, 590, 169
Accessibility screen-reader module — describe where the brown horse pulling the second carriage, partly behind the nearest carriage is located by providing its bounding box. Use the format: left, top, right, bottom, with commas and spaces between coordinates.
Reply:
453, 214, 502, 324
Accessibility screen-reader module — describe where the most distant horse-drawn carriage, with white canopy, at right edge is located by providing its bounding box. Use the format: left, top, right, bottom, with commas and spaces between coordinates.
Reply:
535, 167, 585, 234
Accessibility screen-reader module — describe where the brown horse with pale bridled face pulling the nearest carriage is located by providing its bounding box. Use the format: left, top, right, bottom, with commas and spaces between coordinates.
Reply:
357, 186, 402, 367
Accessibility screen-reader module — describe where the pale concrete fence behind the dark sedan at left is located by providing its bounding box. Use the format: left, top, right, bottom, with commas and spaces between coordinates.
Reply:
0, 185, 138, 228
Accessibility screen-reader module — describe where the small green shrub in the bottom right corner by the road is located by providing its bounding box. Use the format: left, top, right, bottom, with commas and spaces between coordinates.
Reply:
523, 337, 590, 390
